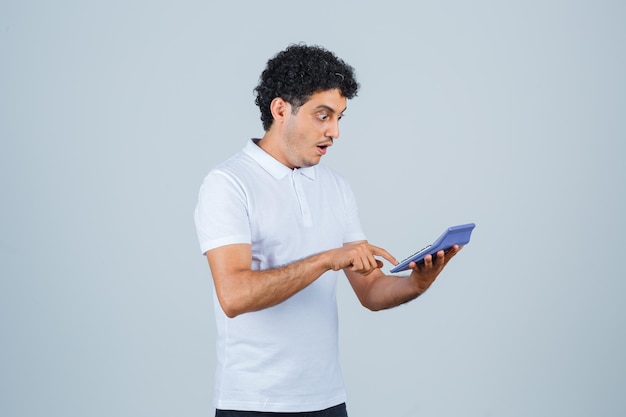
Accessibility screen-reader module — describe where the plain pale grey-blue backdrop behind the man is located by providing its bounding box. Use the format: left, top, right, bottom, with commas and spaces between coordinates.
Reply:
0, 0, 626, 417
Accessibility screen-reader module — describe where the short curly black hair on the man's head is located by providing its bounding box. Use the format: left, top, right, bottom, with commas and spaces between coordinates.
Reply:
254, 44, 359, 131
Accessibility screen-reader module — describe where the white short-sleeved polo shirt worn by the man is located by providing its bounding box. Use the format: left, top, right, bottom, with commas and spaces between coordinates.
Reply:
195, 140, 365, 412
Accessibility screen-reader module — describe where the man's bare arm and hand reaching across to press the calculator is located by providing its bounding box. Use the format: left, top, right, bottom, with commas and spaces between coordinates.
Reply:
206, 241, 397, 318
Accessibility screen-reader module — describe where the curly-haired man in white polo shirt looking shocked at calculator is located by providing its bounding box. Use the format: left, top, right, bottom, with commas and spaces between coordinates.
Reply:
195, 45, 460, 417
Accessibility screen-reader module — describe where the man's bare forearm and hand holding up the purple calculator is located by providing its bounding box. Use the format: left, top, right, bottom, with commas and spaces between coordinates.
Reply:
344, 245, 461, 311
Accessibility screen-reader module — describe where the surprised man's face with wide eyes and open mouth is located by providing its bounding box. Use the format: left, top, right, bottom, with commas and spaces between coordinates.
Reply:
281, 89, 347, 169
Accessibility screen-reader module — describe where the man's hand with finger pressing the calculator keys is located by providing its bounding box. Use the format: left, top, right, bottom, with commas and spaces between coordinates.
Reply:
329, 242, 398, 275
